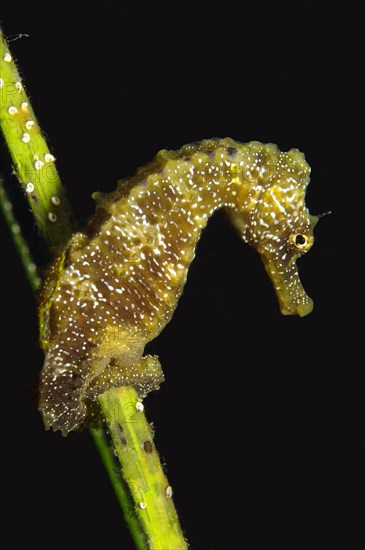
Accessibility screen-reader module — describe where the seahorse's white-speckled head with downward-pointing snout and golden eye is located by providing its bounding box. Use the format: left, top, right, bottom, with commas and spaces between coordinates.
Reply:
228, 149, 318, 317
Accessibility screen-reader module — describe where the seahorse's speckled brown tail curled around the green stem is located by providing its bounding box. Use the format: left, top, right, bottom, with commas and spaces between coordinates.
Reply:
38, 328, 164, 436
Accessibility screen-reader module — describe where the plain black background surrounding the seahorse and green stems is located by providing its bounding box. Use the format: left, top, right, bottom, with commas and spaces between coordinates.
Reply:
0, 2, 364, 550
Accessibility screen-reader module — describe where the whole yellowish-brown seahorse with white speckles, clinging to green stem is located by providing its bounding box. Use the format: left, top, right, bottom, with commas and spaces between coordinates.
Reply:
39, 138, 318, 435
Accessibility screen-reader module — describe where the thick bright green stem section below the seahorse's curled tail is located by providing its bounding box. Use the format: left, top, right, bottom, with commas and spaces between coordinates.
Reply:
99, 387, 187, 550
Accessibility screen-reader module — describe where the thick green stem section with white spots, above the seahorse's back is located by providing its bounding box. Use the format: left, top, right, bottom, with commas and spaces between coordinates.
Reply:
0, 29, 75, 253
